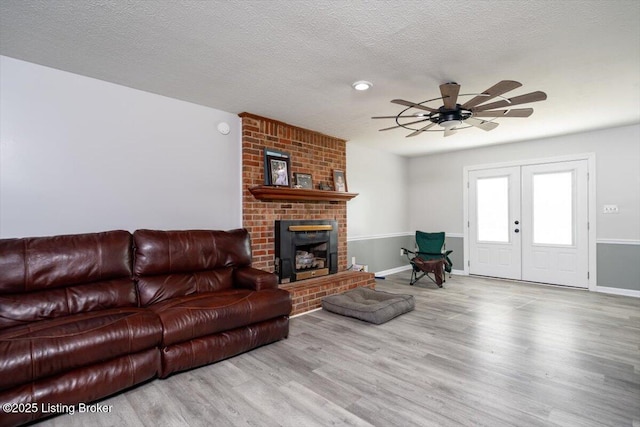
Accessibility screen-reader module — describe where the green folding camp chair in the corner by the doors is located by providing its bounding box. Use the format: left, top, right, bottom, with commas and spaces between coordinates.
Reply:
402, 231, 453, 288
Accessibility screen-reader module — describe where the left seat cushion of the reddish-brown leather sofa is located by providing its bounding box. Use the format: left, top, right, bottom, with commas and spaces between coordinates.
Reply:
0, 308, 162, 390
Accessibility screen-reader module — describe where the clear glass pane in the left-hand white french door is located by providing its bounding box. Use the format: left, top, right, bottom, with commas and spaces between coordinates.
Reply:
477, 176, 509, 243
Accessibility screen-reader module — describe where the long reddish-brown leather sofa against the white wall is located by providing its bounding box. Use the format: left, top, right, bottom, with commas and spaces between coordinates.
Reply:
0, 229, 291, 426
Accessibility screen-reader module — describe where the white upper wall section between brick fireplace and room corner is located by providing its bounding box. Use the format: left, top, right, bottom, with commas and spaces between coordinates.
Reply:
347, 142, 410, 239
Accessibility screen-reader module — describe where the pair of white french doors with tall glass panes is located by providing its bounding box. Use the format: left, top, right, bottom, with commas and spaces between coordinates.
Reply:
468, 160, 589, 288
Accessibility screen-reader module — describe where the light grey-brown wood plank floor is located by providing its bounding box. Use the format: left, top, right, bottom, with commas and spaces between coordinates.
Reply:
39, 273, 640, 427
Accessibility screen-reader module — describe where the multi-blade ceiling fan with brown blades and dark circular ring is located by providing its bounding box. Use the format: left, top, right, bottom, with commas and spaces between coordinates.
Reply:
372, 80, 547, 137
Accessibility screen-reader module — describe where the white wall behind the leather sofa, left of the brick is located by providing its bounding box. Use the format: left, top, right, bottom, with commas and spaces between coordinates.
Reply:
0, 57, 242, 238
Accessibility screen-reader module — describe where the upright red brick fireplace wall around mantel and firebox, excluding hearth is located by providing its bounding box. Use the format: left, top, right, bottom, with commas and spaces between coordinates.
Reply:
240, 113, 347, 271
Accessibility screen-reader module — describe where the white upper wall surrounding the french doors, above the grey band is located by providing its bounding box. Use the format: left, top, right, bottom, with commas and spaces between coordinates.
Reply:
406, 125, 640, 241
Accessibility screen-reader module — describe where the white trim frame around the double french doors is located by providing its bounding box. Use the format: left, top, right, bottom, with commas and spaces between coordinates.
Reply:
462, 153, 598, 291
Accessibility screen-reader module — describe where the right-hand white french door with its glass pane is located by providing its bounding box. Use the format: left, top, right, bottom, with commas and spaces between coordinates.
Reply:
522, 160, 589, 288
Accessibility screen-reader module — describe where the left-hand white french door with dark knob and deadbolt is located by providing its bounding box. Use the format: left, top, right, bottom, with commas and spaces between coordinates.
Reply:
469, 166, 521, 279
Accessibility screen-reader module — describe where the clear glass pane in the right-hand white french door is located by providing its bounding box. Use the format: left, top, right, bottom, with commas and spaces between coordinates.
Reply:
533, 171, 573, 245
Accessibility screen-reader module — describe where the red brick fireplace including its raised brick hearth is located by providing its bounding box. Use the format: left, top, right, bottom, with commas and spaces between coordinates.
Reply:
239, 113, 375, 314
